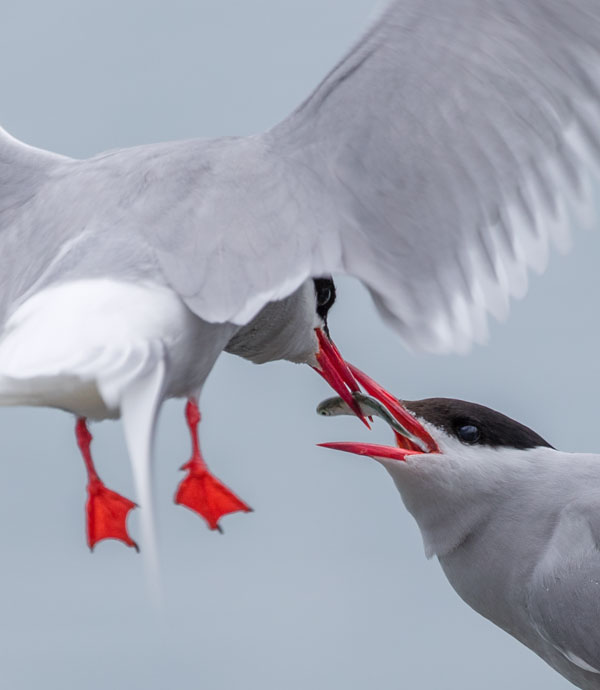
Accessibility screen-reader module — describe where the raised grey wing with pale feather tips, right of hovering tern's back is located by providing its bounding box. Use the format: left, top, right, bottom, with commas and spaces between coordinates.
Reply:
269, 0, 600, 350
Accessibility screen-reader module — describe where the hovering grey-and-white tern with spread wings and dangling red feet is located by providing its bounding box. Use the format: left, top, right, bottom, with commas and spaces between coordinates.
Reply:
0, 0, 600, 551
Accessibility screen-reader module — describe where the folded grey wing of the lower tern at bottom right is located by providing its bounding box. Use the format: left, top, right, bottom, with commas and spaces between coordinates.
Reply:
527, 501, 600, 674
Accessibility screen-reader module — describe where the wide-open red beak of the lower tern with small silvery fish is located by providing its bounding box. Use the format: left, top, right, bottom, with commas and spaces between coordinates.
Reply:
317, 364, 440, 461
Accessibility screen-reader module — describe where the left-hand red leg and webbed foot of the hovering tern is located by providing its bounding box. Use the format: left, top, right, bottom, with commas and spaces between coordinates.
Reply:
75, 417, 139, 551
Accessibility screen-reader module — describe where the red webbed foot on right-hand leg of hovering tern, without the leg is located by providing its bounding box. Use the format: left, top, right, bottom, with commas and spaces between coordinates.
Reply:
175, 459, 252, 532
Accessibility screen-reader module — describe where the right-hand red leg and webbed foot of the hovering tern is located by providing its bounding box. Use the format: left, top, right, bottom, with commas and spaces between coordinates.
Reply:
175, 398, 252, 532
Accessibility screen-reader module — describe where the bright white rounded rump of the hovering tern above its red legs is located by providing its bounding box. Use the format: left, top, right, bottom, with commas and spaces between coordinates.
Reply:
0, 278, 235, 419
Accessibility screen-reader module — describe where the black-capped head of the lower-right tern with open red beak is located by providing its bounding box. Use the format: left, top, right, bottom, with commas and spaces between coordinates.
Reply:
317, 366, 556, 556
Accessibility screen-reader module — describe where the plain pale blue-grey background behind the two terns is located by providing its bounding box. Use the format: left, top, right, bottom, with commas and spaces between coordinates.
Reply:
0, 0, 600, 690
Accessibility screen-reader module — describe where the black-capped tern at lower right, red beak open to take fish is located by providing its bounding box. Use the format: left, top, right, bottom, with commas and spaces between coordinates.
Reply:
317, 369, 600, 690
